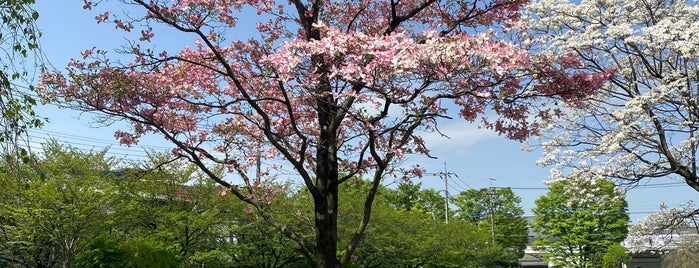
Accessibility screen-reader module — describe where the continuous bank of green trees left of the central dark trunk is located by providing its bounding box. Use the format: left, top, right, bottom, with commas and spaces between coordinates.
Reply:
0, 147, 313, 267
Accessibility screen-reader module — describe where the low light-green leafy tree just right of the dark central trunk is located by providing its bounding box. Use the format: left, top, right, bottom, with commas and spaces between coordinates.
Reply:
354, 204, 505, 267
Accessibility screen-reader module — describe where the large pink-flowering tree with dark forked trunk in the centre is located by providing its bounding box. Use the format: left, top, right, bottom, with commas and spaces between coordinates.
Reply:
40, 0, 609, 267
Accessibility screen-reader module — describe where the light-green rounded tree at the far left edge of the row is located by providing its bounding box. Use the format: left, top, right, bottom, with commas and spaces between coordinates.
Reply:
0, 141, 112, 267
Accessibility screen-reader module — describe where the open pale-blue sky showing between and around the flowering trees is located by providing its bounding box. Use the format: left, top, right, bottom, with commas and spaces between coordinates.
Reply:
31, 1, 697, 222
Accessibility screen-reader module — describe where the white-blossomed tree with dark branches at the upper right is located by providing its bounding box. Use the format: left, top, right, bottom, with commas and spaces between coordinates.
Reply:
527, 0, 699, 191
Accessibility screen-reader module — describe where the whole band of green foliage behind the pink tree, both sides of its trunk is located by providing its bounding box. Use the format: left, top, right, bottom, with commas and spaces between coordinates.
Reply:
0, 146, 536, 267
